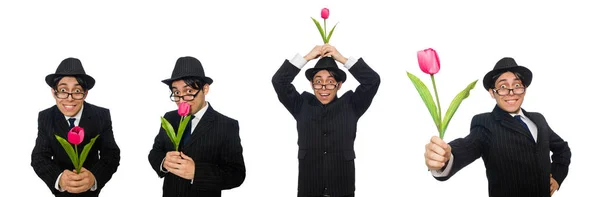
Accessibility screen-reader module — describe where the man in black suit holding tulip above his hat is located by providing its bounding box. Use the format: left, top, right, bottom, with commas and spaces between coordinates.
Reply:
272, 44, 380, 197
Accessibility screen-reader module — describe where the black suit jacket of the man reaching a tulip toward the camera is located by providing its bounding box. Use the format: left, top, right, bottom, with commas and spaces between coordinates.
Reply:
437, 106, 571, 197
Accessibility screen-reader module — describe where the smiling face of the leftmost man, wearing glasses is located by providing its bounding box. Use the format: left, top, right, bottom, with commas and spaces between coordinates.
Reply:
51, 76, 88, 117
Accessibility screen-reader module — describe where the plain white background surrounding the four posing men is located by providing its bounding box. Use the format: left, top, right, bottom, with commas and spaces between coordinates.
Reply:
0, 0, 600, 197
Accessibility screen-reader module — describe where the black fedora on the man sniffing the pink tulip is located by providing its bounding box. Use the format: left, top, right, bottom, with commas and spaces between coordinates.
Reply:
162, 56, 212, 85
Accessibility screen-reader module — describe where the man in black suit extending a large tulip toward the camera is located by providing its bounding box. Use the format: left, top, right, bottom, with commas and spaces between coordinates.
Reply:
425, 58, 571, 197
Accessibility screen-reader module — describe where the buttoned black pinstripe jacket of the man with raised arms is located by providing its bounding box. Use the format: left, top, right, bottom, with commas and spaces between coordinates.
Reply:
272, 58, 380, 196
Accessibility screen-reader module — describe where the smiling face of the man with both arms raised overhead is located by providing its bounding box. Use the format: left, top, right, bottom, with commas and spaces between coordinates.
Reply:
310, 70, 342, 105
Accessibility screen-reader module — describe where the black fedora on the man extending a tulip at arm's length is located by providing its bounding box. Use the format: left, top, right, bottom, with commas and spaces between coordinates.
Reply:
483, 57, 533, 90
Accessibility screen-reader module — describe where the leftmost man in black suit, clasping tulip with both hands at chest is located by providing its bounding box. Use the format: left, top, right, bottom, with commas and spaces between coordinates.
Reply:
31, 58, 121, 196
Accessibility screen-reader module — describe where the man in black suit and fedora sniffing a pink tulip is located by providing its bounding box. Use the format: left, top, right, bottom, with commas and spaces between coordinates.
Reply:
148, 56, 246, 197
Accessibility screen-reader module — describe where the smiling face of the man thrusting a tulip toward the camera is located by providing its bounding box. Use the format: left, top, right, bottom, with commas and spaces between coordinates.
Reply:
488, 72, 526, 113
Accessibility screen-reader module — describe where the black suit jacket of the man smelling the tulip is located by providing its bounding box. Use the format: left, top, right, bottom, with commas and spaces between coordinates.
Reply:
148, 104, 246, 197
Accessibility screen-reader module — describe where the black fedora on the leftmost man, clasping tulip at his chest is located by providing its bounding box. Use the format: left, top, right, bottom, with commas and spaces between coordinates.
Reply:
46, 57, 96, 90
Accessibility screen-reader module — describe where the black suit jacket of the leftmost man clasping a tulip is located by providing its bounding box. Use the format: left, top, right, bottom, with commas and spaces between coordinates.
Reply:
31, 102, 121, 196
